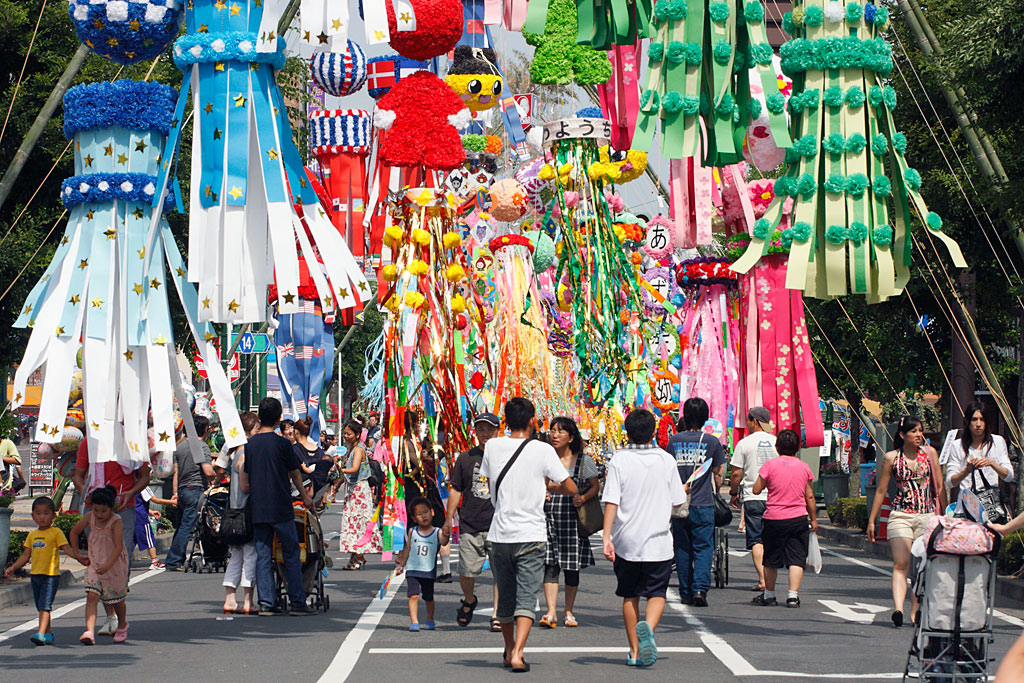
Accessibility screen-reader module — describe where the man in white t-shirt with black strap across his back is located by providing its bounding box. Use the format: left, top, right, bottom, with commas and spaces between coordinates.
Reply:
480, 396, 577, 672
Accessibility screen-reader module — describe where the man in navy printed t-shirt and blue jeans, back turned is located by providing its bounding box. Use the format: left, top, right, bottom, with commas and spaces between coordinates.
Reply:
669, 398, 725, 607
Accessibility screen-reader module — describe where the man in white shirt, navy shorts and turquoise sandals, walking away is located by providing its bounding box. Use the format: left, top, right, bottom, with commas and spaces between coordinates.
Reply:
601, 409, 686, 667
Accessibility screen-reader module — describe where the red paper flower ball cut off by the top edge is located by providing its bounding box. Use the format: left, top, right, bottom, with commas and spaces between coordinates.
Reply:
385, 0, 463, 59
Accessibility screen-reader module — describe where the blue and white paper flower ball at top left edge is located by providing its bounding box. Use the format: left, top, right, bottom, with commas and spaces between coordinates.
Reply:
68, 0, 185, 65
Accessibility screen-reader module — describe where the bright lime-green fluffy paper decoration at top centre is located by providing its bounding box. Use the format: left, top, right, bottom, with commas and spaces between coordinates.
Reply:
523, 0, 611, 85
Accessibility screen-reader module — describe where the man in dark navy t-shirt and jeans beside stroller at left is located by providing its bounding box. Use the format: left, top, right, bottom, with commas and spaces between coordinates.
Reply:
242, 397, 316, 616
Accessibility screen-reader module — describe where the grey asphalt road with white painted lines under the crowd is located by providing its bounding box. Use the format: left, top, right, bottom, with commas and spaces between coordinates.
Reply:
0, 505, 1024, 683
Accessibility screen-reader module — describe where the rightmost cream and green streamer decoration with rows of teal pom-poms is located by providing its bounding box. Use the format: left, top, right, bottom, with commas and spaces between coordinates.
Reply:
733, 0, 967, 301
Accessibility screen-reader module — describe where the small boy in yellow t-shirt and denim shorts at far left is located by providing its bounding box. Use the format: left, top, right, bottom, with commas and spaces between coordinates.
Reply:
4, 496, 89, 645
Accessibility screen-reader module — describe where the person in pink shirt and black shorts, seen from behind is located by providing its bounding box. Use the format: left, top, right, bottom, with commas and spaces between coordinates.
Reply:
752, 429, 818, 607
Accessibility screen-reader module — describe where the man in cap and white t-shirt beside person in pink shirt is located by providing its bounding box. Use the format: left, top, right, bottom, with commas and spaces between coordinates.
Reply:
729, 405, 778, 591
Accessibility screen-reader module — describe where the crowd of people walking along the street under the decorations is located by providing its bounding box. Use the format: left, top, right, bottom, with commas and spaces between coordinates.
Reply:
8, 397, 1024, 672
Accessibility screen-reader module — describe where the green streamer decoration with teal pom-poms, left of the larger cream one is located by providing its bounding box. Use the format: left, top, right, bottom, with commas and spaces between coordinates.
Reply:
633, 0, 790, 165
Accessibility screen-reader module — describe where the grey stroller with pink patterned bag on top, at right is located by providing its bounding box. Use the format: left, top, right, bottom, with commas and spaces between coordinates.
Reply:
903, 516, 999, 683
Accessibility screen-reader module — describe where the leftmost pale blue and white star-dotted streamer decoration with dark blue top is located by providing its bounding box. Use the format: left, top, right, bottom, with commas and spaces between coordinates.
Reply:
12, 81, 245, 464
